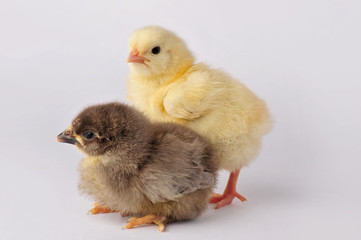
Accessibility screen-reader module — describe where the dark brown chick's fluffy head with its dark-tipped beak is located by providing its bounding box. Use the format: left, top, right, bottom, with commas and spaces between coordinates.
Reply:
57, 103, 147, 156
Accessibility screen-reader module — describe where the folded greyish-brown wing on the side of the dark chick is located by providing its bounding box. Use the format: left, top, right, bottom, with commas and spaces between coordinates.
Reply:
141, 138, 216, 203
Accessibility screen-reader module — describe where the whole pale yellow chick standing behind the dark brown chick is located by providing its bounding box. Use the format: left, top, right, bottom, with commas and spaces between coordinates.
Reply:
127, 26, 271, 208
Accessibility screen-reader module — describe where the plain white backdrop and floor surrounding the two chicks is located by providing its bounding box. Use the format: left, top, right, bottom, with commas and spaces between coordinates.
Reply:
0, 0, 361, 240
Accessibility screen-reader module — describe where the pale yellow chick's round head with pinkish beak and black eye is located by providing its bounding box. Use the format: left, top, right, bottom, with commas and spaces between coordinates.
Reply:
127, 26, 194, 77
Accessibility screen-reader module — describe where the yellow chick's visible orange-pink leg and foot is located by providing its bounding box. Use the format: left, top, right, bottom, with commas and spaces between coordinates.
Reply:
209, 169, 247, 209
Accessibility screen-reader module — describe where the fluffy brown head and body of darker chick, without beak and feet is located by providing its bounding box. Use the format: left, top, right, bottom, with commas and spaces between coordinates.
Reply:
58, 103, 218, 229
